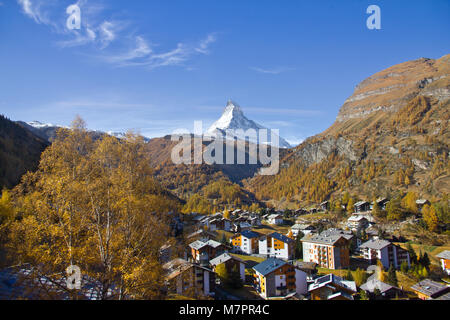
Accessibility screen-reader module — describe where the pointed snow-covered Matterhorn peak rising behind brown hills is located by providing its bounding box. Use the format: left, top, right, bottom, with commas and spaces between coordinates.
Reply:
205, 100, 291, 148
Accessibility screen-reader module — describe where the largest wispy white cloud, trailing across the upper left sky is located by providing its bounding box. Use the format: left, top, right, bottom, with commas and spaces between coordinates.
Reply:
17, 0, 217, 70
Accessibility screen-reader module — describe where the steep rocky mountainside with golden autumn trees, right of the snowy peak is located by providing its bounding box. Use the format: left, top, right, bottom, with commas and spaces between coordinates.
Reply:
245, 55, 450, 206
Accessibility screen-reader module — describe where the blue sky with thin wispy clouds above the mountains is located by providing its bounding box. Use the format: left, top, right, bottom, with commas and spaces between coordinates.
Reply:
0, 0, 450, 144
